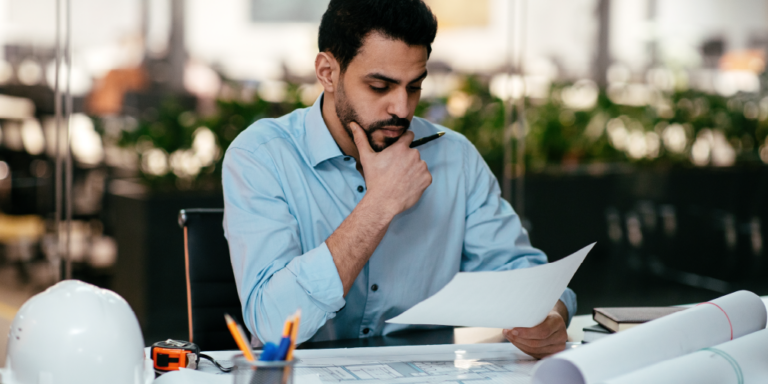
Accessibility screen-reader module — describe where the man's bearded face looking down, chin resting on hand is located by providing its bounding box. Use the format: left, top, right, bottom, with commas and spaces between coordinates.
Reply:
335, 32, 427, 152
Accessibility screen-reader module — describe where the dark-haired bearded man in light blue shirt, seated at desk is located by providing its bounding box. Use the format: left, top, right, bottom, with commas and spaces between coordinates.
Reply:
223, 0, 576, 358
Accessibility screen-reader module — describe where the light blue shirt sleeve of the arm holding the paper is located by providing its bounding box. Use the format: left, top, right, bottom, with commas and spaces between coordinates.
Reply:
461, 142, 576, 326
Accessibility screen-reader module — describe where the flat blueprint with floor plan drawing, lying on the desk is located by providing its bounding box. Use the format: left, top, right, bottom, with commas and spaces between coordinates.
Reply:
294, 343, 536, 384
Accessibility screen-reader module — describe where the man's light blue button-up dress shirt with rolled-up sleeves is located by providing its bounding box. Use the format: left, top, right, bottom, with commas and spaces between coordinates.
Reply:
222, 95, 576, 342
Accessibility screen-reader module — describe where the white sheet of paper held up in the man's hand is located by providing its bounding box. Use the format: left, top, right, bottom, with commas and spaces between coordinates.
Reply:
387, 243, 595, 328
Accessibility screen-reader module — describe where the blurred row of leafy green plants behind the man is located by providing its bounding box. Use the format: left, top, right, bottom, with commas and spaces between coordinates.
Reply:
106, 76, 768, 190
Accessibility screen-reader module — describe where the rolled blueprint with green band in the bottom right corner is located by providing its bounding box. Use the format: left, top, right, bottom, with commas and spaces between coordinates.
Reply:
603, 329, 768, 384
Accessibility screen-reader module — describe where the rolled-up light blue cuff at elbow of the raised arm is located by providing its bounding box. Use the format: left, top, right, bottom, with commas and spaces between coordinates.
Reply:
287, 242, 346, 313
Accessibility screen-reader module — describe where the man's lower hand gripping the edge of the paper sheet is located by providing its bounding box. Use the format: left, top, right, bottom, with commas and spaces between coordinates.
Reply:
502, 300, 568, 359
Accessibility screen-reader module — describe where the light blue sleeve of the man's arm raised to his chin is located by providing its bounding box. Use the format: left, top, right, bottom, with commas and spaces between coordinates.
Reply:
222, 147, 345, 343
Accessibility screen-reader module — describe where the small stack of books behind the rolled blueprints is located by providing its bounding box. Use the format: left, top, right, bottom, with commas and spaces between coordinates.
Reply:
582, 307, 685, 343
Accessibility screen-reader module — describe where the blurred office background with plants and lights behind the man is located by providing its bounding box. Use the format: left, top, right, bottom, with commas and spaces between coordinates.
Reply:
0, 0, 768, 364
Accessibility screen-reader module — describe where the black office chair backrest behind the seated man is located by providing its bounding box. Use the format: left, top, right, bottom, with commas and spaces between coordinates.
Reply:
179, 208, 251, 351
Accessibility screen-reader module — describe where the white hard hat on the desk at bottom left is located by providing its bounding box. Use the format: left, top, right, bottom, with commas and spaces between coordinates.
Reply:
0, 280, 155, 384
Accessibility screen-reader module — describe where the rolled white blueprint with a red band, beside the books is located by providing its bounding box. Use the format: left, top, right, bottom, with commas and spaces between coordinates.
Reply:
532, 291, 766, 384
